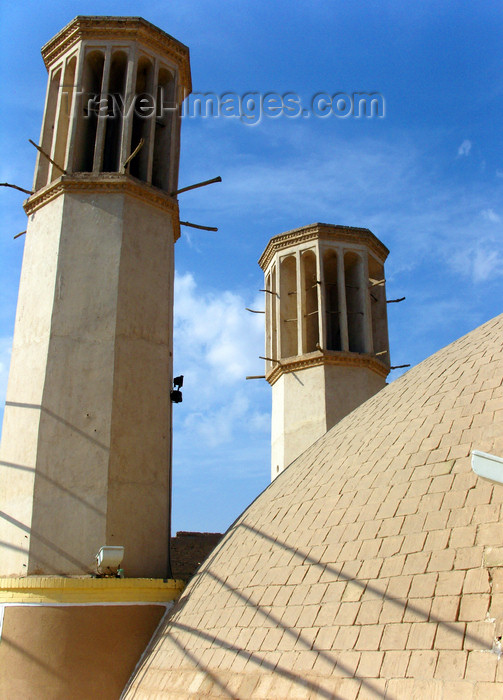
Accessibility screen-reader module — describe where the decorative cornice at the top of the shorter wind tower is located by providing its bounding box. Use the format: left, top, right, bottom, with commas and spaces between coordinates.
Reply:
258, 223, 389, 272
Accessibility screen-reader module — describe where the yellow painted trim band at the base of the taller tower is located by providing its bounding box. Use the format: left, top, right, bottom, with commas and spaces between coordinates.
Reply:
0, 576, 185, 604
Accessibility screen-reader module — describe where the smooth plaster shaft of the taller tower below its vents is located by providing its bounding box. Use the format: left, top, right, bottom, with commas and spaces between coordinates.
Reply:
0, 185, 173, 577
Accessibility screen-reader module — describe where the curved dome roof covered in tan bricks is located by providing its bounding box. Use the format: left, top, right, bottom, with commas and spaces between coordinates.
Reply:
126, 316, 503, 700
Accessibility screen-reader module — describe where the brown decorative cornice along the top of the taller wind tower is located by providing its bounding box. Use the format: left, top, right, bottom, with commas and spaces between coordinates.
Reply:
42, 16, 192, 94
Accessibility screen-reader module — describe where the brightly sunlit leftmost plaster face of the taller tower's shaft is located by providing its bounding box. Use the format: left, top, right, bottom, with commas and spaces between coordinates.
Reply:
0, 198, 63, 575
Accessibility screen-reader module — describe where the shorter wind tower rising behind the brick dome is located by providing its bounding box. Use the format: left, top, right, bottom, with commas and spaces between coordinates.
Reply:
259, 223, 390, 479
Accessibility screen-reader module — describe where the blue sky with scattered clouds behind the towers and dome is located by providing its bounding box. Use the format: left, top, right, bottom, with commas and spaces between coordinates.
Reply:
0, 0, 503, 531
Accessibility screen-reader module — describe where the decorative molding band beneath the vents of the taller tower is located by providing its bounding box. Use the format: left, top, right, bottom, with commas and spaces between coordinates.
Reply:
23, 173, 180, 241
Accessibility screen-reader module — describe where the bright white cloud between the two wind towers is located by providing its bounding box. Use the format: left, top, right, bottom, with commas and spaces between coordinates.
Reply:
174, 274, 270, 465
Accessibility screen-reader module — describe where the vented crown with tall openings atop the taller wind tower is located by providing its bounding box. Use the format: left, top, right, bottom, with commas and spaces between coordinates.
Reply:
34, 16, 191, 192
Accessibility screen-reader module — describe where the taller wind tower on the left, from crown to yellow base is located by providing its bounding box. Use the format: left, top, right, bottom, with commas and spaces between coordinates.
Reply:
0, 17, 191, 578
